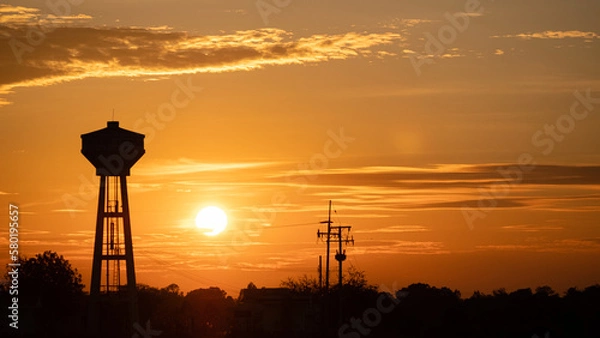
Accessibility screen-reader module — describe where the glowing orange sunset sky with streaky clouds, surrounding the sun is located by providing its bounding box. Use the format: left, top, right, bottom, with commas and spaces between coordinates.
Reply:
0, 0, 600, 296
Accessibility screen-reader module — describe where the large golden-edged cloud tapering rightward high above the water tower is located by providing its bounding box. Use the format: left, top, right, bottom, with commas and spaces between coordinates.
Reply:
0, 18, 401, 105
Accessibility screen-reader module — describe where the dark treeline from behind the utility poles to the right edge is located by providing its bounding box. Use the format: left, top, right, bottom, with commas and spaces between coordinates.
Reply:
268, 271, 600, 338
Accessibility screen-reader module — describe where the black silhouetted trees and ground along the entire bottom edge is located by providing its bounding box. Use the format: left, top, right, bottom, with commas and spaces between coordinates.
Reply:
0, 252, 600, 338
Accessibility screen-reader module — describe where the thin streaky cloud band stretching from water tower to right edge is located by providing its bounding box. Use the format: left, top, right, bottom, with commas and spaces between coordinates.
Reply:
127, 163, 600, 218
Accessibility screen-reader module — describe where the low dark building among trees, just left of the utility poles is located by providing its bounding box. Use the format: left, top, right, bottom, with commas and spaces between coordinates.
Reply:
233, 288, 321, 337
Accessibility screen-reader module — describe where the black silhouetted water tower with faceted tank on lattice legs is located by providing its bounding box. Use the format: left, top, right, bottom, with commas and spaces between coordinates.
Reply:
81, 121, 145, 336
